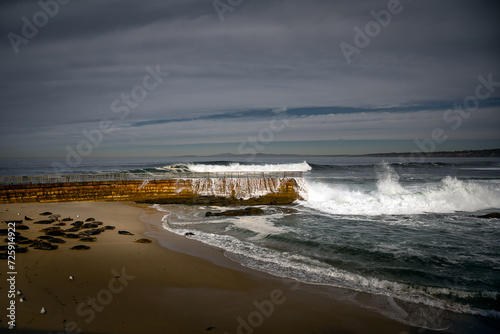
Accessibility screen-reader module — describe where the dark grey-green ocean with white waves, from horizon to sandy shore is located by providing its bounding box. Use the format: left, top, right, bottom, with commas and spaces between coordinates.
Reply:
0, 157, 500, 330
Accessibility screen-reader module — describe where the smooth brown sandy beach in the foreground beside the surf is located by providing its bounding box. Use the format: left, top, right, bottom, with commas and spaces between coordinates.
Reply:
0, 202, 418, 334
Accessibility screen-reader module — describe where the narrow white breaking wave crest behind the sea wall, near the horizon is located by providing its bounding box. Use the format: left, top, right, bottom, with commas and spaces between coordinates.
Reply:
188, 161, 312, 173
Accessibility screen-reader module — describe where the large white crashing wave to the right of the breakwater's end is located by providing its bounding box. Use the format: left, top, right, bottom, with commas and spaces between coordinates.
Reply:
301, 164, 500, 215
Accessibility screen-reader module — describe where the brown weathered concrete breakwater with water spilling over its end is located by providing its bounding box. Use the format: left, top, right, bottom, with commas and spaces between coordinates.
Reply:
0, 172, 302, 205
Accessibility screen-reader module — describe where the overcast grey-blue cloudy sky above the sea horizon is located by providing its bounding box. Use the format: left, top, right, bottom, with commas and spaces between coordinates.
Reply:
0, 0, 500, 157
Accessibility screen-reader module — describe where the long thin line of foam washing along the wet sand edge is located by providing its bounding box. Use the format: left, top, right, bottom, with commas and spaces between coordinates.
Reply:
157, 216, 500, 318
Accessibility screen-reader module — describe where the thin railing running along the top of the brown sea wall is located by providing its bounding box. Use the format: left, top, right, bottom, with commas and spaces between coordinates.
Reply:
0, 171, 303, 185
